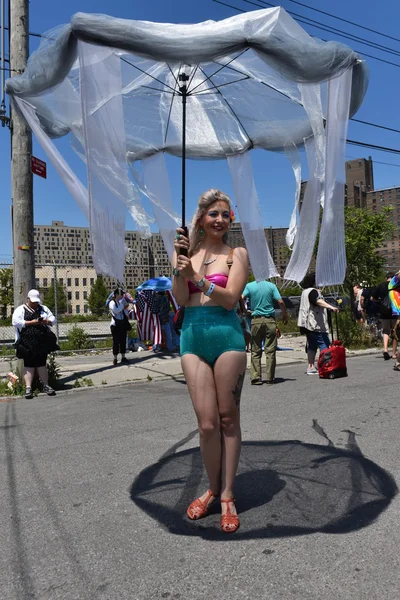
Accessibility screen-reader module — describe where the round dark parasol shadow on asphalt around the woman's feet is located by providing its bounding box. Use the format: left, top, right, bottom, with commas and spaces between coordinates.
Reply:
130, 431, 397, 541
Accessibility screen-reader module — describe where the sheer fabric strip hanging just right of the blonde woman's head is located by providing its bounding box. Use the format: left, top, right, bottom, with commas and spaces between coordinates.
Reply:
228, 152, 279, 281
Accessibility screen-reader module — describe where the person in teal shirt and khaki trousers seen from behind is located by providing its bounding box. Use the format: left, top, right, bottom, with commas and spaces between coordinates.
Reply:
243, 281, 287, 385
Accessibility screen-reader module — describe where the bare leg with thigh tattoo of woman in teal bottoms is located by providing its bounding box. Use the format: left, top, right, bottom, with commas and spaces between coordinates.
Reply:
214, 352, 246, 514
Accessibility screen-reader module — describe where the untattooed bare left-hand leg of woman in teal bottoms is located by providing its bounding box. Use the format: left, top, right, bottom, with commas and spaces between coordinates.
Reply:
182, 354, 221, 500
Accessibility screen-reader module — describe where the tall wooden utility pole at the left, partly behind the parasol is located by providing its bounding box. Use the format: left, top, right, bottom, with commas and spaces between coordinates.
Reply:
9, 0, 35, 306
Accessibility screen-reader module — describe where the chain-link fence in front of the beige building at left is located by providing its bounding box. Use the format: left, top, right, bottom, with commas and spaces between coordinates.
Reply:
0, 263, 148, 354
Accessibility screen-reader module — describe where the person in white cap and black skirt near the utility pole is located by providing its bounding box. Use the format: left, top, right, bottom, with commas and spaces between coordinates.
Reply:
12, 290, 58, 399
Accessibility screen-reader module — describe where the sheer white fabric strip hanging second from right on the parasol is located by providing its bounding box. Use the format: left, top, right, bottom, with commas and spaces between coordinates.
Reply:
285, 138, 323, 282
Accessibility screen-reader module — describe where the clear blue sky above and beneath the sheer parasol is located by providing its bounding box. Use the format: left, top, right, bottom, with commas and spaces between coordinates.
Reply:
0, 0, 400, 260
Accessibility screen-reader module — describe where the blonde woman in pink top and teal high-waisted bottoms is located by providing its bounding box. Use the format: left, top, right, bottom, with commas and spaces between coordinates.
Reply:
172, 189, 248, 533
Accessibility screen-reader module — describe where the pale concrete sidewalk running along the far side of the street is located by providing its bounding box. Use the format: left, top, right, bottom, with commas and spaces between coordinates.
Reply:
0, 335, 381, 390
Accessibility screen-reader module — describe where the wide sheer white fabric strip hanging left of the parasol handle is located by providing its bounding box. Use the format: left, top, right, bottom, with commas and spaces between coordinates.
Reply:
78, 42, 130, 281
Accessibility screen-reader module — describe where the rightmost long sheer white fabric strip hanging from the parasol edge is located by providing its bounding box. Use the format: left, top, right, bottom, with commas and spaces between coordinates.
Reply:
316, 69, 352, 286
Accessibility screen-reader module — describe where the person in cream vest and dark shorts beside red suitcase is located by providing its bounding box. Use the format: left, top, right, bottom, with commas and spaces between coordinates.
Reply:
297, 273, 339, 375
